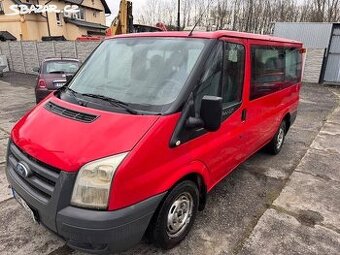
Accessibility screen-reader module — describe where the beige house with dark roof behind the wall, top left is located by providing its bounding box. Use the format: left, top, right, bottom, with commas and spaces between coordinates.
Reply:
0, 0, 111, 41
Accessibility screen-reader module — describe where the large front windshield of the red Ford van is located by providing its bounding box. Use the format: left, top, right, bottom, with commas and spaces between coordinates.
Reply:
69, 38, 207, 112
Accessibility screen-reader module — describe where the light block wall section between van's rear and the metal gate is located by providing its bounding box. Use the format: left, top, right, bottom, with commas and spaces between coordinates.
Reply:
303, 49, 325, 83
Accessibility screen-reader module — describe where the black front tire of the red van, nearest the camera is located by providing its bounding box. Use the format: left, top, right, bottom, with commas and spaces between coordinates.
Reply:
147, 181, 199, 249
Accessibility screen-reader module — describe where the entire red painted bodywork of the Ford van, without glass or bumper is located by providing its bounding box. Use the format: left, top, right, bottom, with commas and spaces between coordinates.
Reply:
12, 31, 302, 210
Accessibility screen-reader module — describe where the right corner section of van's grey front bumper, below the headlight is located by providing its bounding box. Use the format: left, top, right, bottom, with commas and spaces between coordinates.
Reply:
57, 194, 164, 254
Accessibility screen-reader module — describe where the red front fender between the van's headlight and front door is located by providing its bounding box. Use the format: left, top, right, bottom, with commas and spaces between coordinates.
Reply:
109, 114, 211, 210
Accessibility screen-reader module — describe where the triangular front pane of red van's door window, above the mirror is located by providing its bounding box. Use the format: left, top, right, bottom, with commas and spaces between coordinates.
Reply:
195, 43, 223, 114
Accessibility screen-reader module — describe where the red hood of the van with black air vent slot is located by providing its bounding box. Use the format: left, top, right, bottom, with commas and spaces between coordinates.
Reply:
11, 97, 159, 172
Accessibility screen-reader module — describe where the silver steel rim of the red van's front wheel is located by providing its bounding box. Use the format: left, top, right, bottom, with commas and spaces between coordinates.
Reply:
167, 192, 194, 237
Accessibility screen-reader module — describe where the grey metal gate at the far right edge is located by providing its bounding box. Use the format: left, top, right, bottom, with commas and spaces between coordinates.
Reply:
324, 25, 340, 83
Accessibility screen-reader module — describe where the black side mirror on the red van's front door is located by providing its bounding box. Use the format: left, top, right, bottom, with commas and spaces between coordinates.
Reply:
200, 96, 222, 132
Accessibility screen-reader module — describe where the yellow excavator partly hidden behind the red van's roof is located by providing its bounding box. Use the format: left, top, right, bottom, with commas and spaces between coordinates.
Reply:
106, 0, 167, 36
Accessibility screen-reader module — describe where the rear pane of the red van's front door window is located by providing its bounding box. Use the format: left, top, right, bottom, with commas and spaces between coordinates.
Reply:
222, 42, 245, 108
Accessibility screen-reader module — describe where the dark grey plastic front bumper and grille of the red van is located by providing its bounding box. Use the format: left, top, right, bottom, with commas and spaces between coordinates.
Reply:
6, 142, 165, 254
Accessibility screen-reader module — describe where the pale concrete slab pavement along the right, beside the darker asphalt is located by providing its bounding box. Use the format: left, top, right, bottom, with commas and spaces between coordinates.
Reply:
240, 90, 340, 255
